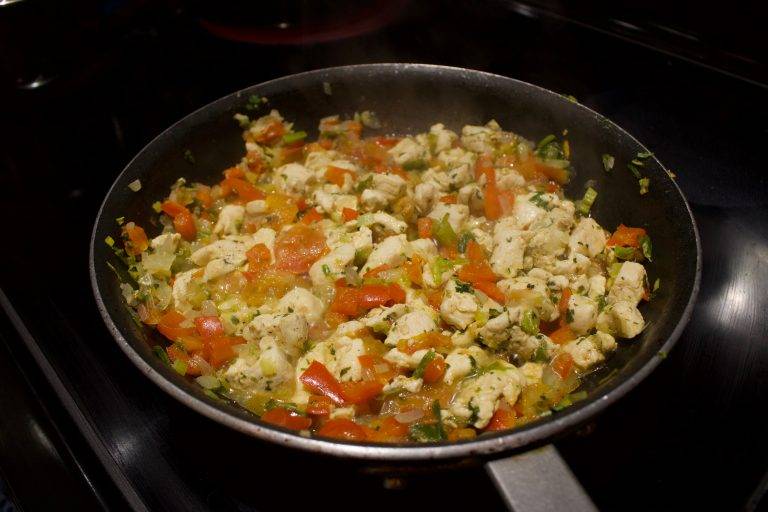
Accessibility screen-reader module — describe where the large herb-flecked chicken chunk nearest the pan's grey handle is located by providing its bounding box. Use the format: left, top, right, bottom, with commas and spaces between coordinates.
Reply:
450, 365, 526, 428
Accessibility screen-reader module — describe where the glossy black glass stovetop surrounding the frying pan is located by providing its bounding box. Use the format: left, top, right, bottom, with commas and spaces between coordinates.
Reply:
0, 1, 768, 511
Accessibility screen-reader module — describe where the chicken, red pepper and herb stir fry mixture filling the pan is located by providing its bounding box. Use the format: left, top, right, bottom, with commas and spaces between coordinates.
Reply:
114, 110, 651, 442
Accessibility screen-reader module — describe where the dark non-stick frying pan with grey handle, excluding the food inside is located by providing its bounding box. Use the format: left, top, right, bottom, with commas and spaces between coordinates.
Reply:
90, 64, 701, 510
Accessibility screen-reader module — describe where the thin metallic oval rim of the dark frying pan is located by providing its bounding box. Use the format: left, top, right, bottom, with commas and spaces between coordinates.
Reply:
88, 63, 702, 461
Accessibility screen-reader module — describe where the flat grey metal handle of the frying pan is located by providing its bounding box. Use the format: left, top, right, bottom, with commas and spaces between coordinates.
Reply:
485, 444, 597, 512
